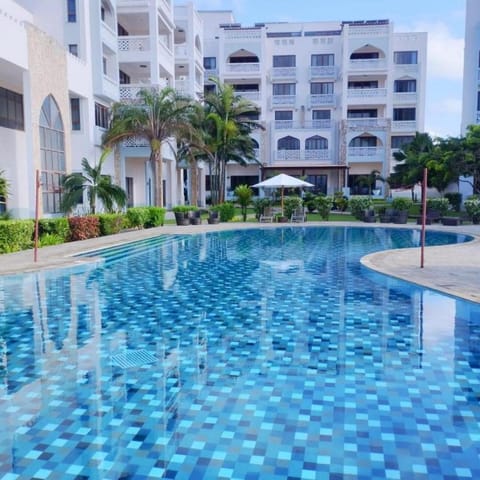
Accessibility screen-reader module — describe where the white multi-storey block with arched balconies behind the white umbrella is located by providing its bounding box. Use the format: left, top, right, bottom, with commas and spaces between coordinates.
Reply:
200, 11, 427, 194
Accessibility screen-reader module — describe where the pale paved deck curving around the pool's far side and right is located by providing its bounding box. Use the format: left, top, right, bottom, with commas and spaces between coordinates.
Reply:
0, 222, 480, 303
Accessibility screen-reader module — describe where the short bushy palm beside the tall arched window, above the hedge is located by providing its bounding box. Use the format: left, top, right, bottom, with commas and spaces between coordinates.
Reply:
61, 149, 127, 214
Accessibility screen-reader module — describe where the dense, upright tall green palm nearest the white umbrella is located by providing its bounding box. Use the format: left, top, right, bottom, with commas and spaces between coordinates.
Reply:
204, 79, 263, 204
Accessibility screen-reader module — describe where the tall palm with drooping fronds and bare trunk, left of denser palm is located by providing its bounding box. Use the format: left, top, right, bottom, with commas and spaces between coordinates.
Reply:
103, 87, 191, 207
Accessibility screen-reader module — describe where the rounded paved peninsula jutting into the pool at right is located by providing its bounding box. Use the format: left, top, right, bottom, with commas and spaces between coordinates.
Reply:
360, 229, 480, 303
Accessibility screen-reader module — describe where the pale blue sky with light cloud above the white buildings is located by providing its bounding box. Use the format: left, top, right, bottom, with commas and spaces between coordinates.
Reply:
175, 0, 464, 136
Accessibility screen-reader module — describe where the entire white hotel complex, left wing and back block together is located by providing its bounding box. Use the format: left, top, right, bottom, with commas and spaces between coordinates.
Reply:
0, 0, 426, 218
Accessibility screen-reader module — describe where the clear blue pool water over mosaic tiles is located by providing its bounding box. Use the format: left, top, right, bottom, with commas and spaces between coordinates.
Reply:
0, 227, 480, 480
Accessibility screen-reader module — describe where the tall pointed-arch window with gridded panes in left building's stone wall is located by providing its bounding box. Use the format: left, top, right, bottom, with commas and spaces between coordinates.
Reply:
39, 95, 66, 213
